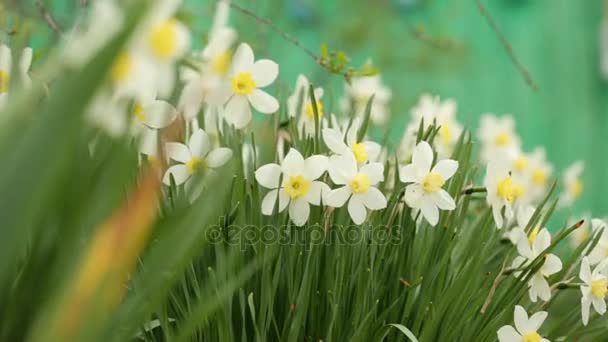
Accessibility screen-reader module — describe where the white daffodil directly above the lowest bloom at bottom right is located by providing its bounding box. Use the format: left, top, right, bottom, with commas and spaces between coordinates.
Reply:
511, 228, 562, 303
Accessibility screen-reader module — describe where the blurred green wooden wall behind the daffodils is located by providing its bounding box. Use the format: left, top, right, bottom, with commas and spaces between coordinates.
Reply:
21, 0, 608, 215
